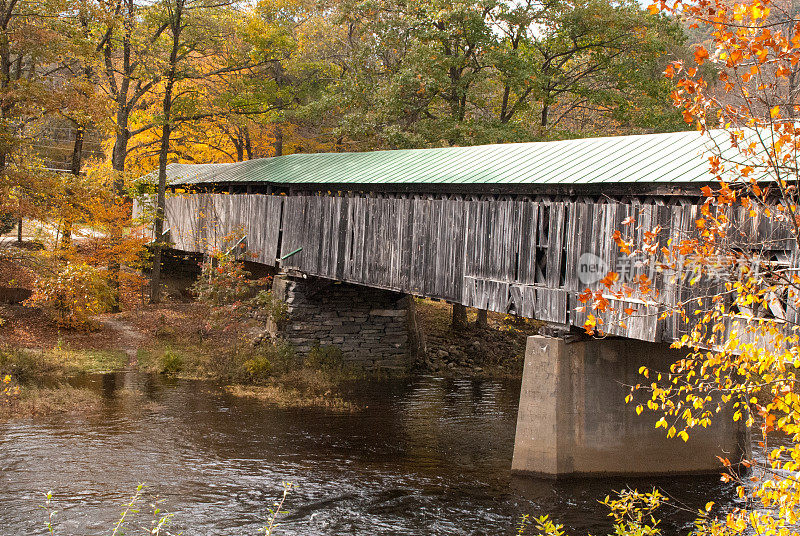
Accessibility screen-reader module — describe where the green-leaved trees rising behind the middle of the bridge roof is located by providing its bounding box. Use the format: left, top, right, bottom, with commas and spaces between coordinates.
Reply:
325, 0, 683, 148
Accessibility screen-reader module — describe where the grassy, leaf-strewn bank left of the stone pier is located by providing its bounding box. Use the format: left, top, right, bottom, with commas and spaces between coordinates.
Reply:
0, 303, 363, 419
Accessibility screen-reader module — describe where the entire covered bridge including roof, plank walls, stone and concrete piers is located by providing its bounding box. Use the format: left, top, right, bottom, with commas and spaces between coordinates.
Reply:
141, 132, 764, 480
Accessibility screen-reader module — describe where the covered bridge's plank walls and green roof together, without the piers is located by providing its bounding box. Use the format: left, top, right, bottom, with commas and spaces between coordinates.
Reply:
145, 131, 794, 341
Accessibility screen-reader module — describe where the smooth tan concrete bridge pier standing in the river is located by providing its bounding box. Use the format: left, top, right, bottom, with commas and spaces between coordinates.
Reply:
512, 336, 750, 478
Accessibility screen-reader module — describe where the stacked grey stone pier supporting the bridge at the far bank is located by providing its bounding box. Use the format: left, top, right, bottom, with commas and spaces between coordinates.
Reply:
273, 275, 409, 369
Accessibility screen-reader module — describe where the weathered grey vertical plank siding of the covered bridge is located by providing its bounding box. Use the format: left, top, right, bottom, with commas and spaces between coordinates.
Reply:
136, 193, 800, 341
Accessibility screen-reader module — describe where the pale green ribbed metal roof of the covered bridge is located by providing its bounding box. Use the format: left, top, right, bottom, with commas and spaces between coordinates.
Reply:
162, 130, 744, 185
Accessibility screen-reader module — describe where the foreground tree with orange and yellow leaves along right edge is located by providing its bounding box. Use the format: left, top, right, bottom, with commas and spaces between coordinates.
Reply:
568, 0, 800, 535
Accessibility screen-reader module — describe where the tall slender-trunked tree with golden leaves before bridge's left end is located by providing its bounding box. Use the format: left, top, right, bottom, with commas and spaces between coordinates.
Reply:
145, 0, 298, 302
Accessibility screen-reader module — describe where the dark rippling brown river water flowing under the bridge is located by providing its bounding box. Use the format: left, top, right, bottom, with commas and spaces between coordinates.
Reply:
0, 373, 734, 536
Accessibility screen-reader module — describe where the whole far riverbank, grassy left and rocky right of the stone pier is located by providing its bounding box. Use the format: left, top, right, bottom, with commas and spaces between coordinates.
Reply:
0, 300, 537, 419
